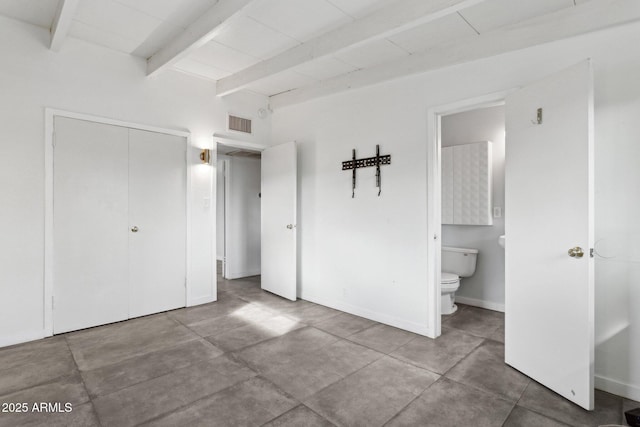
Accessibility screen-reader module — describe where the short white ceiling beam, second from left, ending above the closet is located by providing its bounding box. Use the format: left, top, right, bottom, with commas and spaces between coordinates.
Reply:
147, 0, 252, 76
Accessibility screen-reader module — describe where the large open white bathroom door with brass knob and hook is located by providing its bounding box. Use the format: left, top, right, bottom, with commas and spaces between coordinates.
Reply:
505, 61, 594, 409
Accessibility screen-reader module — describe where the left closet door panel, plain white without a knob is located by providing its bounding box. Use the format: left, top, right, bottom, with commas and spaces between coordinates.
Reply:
53, 117, 129, 334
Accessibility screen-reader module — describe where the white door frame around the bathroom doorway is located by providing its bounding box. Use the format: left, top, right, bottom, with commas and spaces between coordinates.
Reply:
426, 88, 518, 338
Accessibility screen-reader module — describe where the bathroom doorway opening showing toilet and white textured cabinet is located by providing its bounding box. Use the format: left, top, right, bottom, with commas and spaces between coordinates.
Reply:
439, 101, 505, 321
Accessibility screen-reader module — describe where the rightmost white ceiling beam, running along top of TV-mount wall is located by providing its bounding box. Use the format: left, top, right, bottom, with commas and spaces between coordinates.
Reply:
270, 0, 640, 109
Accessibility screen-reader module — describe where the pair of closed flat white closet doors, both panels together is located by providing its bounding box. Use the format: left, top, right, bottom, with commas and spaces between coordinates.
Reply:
53, 117, 186, 333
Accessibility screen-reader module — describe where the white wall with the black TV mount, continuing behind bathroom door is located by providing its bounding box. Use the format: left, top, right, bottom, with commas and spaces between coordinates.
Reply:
271, 23, 640, 400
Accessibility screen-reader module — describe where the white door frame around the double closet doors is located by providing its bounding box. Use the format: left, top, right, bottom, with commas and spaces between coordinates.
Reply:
43, 107, 191, 337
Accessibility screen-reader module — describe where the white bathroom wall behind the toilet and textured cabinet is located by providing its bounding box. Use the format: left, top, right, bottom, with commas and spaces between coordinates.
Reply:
441, 106, 505, 311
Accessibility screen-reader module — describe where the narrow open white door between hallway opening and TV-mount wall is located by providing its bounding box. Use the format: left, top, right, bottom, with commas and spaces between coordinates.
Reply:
261, 142, 297, 301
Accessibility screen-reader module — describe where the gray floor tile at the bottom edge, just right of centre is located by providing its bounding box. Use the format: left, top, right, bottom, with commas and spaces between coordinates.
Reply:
305, 357, 440, 427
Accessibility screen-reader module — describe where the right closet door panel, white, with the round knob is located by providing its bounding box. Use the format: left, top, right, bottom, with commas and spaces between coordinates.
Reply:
128, 129, 186, 317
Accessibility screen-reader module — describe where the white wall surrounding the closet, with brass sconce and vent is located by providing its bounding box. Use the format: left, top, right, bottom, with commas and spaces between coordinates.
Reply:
0, 17, 270, 346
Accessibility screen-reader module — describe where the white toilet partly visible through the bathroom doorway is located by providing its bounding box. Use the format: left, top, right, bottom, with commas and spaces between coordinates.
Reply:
440, 246, 478, 314
